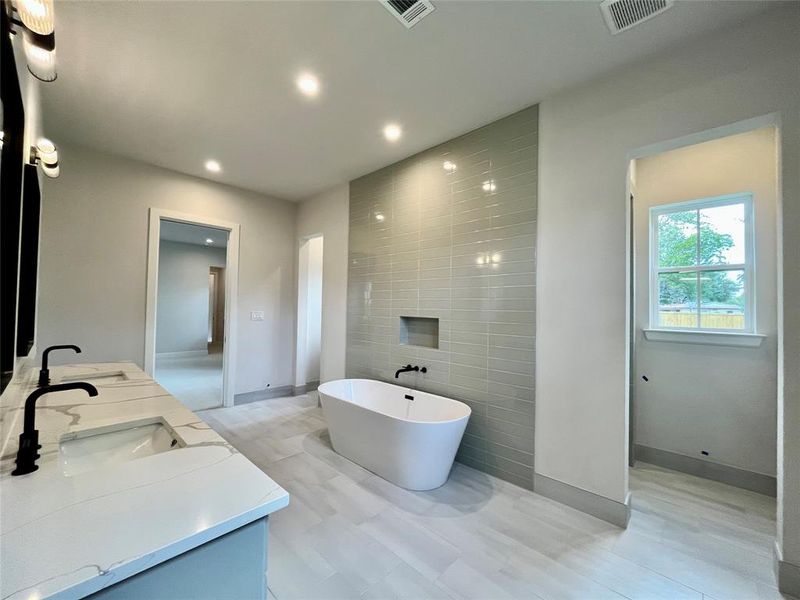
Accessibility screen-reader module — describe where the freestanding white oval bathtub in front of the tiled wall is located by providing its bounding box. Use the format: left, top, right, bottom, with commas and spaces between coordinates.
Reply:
319, 379, 472, 490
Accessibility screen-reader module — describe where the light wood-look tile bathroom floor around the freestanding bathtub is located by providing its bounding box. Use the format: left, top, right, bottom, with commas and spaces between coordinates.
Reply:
200, 394, 781, 600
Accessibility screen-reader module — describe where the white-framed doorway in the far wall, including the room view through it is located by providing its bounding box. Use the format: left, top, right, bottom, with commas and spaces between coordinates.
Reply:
145, 209, 239, 411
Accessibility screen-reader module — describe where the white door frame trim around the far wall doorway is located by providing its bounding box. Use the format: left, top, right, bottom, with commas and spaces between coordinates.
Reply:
144, 207, 241, 406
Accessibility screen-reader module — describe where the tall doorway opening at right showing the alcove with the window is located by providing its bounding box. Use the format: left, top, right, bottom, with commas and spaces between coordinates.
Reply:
628, 118, 780, 589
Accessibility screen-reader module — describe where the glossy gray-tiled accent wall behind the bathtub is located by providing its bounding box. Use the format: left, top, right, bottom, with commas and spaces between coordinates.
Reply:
347, 106, 538, 489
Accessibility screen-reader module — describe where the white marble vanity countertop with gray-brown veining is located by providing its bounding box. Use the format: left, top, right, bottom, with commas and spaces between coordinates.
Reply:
0, 363, 289, 600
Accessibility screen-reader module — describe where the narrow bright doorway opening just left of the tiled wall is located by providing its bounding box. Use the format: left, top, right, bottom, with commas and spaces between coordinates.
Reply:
294, 235, 323, 394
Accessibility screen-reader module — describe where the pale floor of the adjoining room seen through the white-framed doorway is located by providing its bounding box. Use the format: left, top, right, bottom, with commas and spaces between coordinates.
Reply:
155, 350, 222, 411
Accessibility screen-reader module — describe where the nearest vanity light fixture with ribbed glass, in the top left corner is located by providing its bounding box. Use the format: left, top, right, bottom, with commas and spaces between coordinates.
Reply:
10, 0, 57, 82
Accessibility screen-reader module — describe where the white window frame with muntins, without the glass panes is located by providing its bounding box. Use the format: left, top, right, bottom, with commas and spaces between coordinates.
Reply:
649, 192, 756, 334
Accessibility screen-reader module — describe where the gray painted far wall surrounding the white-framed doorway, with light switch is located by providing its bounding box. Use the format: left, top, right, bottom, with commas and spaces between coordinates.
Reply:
37, 144, 297, 394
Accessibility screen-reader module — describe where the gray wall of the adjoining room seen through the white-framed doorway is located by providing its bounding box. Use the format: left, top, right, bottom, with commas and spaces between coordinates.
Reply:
156, 240, 225, 353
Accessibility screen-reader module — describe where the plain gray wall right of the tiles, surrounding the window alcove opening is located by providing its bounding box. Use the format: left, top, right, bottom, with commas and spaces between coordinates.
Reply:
536, 8, 800, 520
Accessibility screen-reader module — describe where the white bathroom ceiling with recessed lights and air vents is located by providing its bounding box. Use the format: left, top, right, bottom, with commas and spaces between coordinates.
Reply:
42, 0, 770, 200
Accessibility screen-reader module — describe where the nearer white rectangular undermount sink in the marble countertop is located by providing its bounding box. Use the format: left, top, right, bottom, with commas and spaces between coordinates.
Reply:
59, 419, 185, 476
